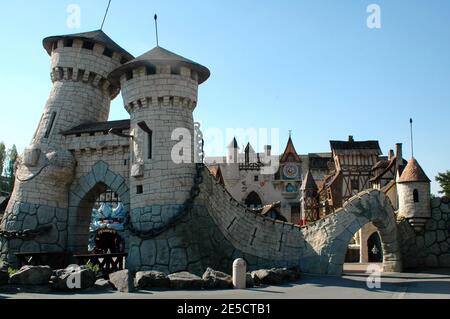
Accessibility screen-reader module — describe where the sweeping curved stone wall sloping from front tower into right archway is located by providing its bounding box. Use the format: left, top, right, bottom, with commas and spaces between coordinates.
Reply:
128, 170, 401, 275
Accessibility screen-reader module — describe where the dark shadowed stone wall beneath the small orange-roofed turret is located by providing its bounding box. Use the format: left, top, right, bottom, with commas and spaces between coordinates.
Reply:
398, 198, 450, 268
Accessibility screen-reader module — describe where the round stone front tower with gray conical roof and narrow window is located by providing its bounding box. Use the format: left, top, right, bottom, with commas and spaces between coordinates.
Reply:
109, 47, 210, 268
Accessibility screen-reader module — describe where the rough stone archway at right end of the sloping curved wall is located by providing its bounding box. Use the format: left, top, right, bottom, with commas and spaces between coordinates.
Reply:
301, 190, 402, 275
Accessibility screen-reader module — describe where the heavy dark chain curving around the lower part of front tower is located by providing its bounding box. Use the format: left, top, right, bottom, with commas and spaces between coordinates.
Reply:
126, 163, 204, 239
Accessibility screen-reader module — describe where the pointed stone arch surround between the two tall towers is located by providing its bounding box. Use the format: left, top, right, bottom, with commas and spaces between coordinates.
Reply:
67, 161, 130, 253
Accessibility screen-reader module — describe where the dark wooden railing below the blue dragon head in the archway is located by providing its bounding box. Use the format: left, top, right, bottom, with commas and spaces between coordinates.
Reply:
74, 253, 128, 278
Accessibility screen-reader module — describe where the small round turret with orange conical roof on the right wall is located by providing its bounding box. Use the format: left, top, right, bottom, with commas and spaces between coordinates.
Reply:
397, 157, 431, 231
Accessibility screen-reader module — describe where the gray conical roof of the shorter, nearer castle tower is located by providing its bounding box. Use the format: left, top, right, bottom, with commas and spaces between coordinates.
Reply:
109, 46, 210, 84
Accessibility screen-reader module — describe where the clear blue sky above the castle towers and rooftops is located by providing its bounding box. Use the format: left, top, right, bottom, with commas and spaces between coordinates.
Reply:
0, 0, 450, 193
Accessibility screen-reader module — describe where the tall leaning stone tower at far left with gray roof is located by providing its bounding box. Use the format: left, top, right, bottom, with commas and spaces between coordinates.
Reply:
2, 30, 133, 262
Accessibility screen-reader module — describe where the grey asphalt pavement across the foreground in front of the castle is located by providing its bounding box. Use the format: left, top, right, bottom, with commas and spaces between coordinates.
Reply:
0, 269, 450, 299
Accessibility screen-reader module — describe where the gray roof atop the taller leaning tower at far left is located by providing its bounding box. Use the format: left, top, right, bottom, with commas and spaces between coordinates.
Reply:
42, 30, 134, 61
